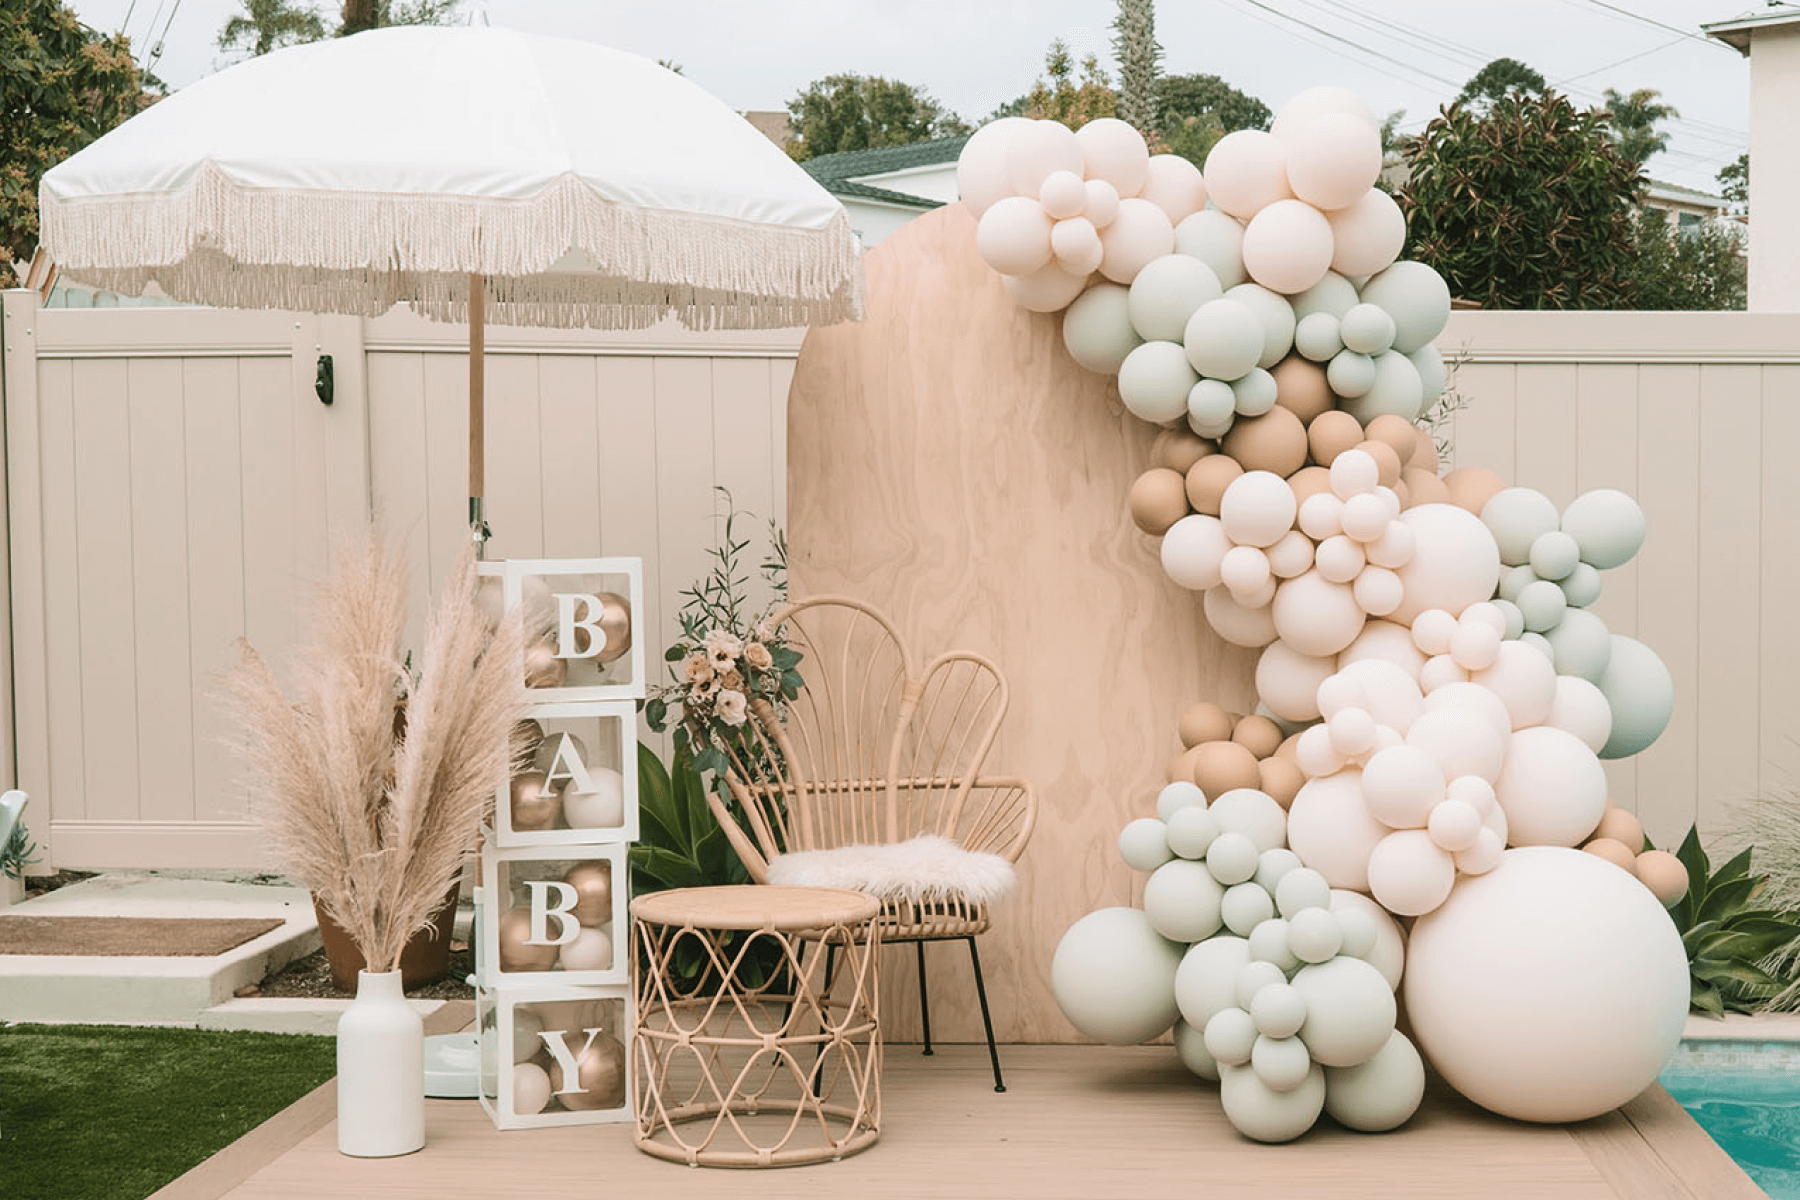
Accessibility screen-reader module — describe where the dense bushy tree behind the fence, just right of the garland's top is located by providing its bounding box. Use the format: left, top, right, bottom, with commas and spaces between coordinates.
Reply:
1399, 94, 1643, 308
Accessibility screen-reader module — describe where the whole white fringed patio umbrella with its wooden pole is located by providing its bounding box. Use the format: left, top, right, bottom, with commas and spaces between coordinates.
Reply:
40, 27, 862, 542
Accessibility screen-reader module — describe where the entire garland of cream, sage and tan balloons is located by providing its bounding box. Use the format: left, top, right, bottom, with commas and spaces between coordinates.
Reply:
958, 88, 1687, 1141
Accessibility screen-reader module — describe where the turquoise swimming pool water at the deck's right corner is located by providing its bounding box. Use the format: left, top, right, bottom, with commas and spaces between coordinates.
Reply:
1660, 1040, 1800, 1200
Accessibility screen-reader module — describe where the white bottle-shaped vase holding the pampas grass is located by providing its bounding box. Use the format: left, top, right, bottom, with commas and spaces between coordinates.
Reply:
338, 972, 425, 1159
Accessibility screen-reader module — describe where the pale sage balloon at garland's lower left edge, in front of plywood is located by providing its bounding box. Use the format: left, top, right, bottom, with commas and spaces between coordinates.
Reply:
1049, 909, 1183, 1045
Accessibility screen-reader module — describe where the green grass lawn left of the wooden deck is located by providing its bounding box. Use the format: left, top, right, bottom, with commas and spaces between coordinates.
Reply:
0, 1025, 337, 1200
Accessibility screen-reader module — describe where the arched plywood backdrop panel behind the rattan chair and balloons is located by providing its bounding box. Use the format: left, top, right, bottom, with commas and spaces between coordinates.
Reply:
787, 205, 1251, 1042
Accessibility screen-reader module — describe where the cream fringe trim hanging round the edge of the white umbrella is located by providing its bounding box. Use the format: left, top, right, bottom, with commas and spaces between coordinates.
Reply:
40, 164, 864, 329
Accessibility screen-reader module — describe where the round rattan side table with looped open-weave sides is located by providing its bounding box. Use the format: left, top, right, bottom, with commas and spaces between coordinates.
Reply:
632, 885, 882, 1168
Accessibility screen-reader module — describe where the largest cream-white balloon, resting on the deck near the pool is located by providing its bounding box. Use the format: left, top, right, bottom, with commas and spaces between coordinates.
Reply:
1404, 847, 1688, 1123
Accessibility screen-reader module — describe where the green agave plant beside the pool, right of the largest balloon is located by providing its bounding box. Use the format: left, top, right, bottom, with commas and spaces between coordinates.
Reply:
1669, 828, 1800, 1016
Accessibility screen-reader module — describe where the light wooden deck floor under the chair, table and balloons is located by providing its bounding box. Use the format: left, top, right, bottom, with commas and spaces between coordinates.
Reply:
155, 1045, 1762, 1200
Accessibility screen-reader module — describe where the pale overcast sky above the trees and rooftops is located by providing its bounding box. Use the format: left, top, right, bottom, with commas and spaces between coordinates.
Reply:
68, 0, 1759, 191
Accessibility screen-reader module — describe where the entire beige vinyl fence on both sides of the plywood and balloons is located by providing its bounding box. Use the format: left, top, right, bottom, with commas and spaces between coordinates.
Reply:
0, 291, 1800, 867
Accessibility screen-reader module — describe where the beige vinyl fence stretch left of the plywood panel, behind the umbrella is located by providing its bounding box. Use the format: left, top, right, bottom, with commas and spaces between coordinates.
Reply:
0, 291, 799, 867
